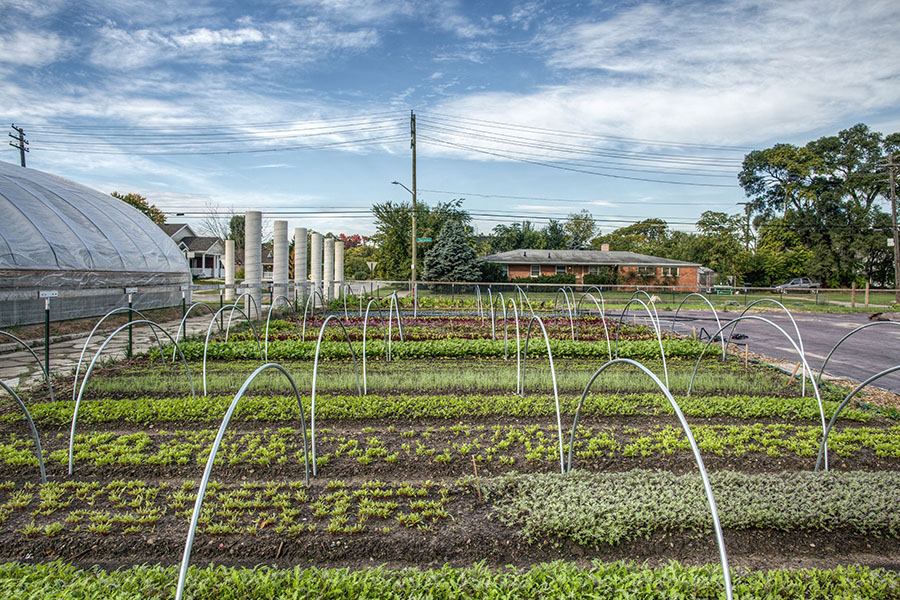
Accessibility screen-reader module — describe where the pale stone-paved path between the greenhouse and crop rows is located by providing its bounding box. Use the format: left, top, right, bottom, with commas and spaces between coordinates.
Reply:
0, 314, 217, 399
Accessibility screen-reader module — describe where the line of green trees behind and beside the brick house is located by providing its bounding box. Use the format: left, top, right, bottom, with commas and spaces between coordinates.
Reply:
372, 124, 900, 287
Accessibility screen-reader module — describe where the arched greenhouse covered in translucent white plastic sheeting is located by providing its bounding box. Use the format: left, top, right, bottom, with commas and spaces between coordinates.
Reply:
0, 162, 191, 326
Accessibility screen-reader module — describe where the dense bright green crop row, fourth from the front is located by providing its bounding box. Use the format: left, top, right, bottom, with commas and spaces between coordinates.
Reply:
2, 393, 873, 426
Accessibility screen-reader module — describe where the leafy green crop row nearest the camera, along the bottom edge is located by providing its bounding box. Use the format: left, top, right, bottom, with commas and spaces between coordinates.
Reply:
7, 562, 900, 600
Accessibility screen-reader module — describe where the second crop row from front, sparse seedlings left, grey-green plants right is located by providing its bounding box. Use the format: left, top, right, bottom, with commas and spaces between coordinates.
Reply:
0, 470, 900, 548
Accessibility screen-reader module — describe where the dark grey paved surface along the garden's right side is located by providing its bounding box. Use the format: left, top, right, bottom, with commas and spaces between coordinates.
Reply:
652, 309, 900, 393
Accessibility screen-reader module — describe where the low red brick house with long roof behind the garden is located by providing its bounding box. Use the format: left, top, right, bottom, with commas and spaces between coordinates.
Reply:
482, 249, 702, 291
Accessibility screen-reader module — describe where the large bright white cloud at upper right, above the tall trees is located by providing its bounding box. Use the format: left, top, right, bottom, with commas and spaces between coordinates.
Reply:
437, 0, 900, 145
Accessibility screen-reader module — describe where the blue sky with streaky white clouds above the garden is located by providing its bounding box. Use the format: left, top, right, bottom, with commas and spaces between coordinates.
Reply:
0, 0, 900, 241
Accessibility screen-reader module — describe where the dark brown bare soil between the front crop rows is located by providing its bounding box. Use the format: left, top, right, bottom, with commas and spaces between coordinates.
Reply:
0, 342, 900, 569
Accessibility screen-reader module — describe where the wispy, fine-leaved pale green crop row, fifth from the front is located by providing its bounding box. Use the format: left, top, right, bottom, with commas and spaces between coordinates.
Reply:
86, 357, 800, 397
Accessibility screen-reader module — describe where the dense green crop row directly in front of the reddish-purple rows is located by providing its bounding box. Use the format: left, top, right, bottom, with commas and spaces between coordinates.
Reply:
162, 334, 705, 361
